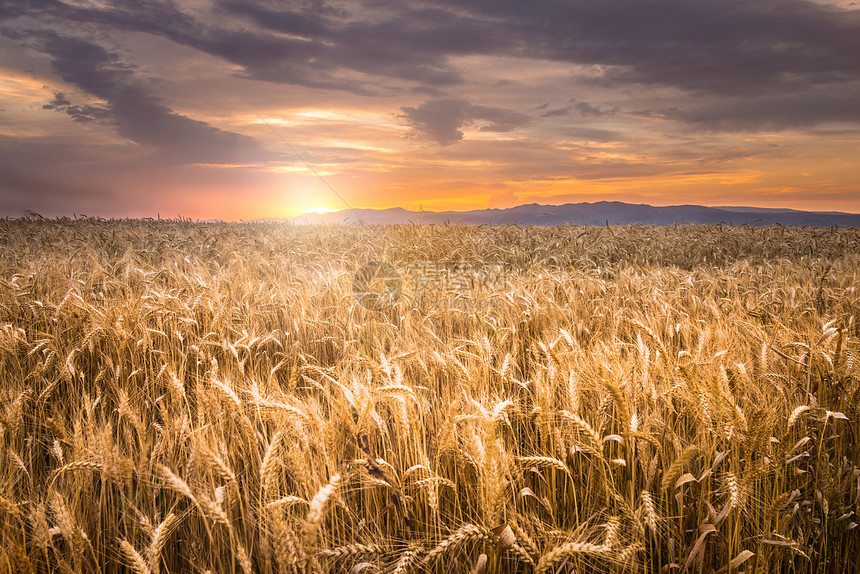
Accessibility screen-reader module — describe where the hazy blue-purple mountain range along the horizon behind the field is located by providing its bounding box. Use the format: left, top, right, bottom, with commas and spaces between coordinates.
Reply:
289, 201, 860, 227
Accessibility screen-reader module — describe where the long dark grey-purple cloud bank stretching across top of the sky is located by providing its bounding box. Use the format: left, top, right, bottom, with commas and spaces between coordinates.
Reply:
5, 0, 860, 119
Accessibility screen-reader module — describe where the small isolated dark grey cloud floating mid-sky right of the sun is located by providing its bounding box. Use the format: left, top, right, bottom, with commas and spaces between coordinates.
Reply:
401, 99, 531, 145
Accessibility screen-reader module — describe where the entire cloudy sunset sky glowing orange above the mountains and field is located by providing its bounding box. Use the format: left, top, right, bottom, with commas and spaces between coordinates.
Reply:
0, 0, 860, 220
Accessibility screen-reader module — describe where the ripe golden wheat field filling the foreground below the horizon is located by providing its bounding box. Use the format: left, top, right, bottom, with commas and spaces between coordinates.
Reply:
0, 219, 860, 574
